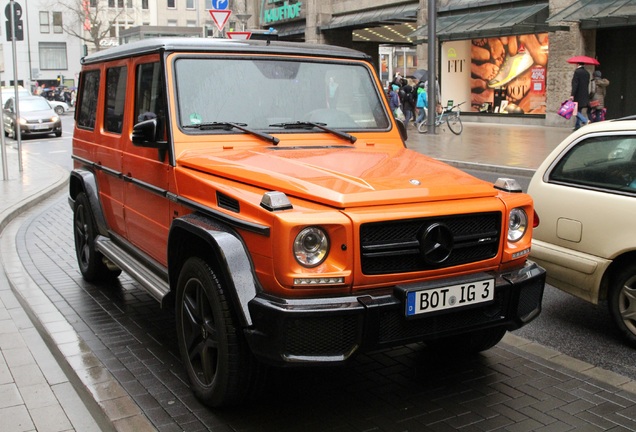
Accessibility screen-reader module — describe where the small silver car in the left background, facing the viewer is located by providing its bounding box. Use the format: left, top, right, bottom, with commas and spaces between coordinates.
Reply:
2, 96, 62, 138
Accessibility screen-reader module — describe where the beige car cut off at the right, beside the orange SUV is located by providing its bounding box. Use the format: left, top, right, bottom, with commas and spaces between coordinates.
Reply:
528, 116, 636, 346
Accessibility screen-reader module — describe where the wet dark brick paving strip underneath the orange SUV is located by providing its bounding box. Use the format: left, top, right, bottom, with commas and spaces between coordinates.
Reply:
3, 191, 636, 431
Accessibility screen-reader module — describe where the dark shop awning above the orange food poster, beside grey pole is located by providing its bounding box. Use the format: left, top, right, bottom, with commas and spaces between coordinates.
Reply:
408, 4, 568, 43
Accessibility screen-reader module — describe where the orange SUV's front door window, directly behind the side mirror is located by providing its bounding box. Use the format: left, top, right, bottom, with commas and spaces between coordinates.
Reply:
135, 62, 166, 139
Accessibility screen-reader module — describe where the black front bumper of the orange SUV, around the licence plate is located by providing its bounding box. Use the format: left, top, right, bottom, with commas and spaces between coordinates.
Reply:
246, 261, 545, 365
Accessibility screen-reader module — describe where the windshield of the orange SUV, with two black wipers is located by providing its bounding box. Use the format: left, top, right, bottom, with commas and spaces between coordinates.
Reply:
175, 58, 389, 133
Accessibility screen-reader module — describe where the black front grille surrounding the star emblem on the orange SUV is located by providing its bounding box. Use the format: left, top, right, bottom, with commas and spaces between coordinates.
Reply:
360, 212, 501, 274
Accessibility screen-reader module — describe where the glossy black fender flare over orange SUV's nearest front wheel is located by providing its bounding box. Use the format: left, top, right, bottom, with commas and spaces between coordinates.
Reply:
168, 213, 262, 327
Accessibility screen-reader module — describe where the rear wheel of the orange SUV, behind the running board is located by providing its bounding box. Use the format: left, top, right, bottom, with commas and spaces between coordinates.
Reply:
73, 192, 121, 282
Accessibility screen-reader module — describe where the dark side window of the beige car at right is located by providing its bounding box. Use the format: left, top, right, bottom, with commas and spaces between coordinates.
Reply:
549, 135, 636, 192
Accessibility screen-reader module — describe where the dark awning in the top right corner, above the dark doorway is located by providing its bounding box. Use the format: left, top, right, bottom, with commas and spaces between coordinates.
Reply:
547, 0, 636, 29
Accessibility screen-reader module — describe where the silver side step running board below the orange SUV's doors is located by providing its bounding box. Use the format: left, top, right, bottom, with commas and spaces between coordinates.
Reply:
95, 236, 170, 303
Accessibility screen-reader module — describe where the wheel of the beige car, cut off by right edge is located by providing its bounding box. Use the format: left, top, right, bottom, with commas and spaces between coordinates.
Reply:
608, 264, 636, 346
